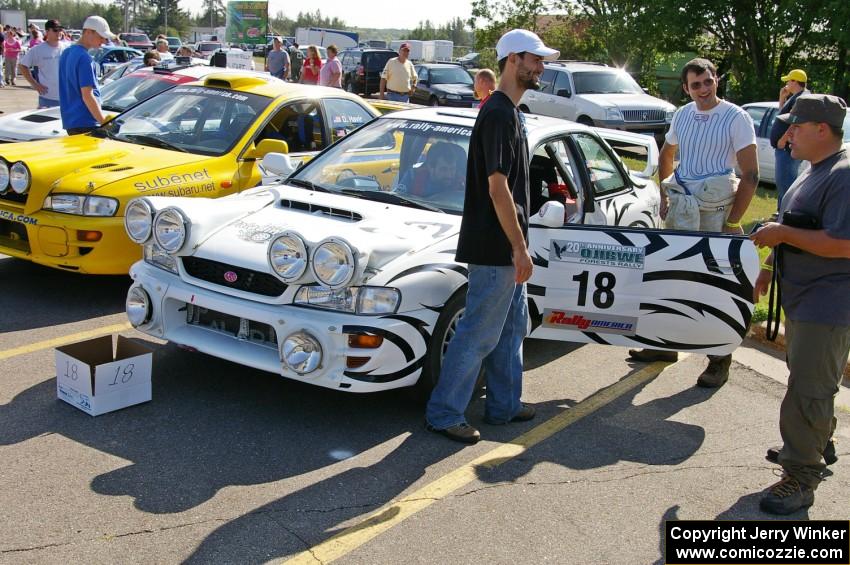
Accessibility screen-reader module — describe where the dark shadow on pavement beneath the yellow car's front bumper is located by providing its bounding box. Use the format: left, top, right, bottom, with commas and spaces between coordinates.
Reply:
0, 258, 132, 333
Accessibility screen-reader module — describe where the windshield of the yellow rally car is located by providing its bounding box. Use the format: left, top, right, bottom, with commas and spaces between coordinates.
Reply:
98, 86, 271, 156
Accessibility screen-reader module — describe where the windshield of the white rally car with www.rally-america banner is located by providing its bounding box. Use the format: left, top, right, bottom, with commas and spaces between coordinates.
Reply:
290, 117, 472, 214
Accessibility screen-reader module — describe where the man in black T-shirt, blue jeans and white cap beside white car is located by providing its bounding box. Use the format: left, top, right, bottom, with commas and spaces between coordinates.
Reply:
425, 29, 559, 444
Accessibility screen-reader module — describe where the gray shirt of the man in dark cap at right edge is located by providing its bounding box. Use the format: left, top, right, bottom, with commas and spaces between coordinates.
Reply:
780, 149, 850, 326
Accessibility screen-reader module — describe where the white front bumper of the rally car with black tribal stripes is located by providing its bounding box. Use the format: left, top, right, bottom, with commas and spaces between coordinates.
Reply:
130, 261, 433, 393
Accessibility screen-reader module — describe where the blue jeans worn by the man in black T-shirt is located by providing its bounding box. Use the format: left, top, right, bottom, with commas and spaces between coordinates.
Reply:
425, 265, 528, 430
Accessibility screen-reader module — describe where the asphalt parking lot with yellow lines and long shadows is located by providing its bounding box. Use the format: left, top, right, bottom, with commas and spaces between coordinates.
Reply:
0, 83, 850, 564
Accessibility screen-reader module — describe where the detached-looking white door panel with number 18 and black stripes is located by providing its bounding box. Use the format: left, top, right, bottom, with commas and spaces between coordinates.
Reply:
528, 225, 759, 355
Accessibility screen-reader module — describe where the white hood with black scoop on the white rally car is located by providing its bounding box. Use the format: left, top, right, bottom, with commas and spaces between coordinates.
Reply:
189, 186, 460, 284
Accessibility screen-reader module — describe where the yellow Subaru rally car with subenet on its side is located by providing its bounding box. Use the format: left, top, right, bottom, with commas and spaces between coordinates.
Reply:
0, 72, 378, 274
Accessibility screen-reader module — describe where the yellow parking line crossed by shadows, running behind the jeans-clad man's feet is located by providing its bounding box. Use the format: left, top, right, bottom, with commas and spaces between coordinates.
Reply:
285, 357, 684, 565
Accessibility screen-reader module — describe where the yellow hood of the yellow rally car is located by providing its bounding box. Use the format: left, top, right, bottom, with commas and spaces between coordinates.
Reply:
0, 135, 209, 213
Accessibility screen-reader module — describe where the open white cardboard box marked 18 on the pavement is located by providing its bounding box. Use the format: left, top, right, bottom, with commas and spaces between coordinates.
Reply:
56, 335, 153, 416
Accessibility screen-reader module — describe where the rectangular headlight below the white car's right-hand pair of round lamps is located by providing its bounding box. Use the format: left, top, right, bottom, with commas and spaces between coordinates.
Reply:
293, 285, 401, 315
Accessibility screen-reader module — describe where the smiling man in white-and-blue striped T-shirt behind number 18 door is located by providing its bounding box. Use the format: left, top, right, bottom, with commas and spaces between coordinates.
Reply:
629, 58, 759, 388
